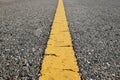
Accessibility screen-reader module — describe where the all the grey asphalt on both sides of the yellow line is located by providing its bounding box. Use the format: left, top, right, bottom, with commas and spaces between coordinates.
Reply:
0, 0, 120, 80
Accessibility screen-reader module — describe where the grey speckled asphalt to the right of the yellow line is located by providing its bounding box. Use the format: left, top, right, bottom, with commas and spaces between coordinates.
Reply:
63, 0, 120, 80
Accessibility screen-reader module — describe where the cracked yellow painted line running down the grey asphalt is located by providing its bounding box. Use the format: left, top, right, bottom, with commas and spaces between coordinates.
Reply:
39, 0, 81, 80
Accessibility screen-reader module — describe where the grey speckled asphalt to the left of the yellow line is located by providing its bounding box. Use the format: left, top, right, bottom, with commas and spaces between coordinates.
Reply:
0, 0, 58, 80
